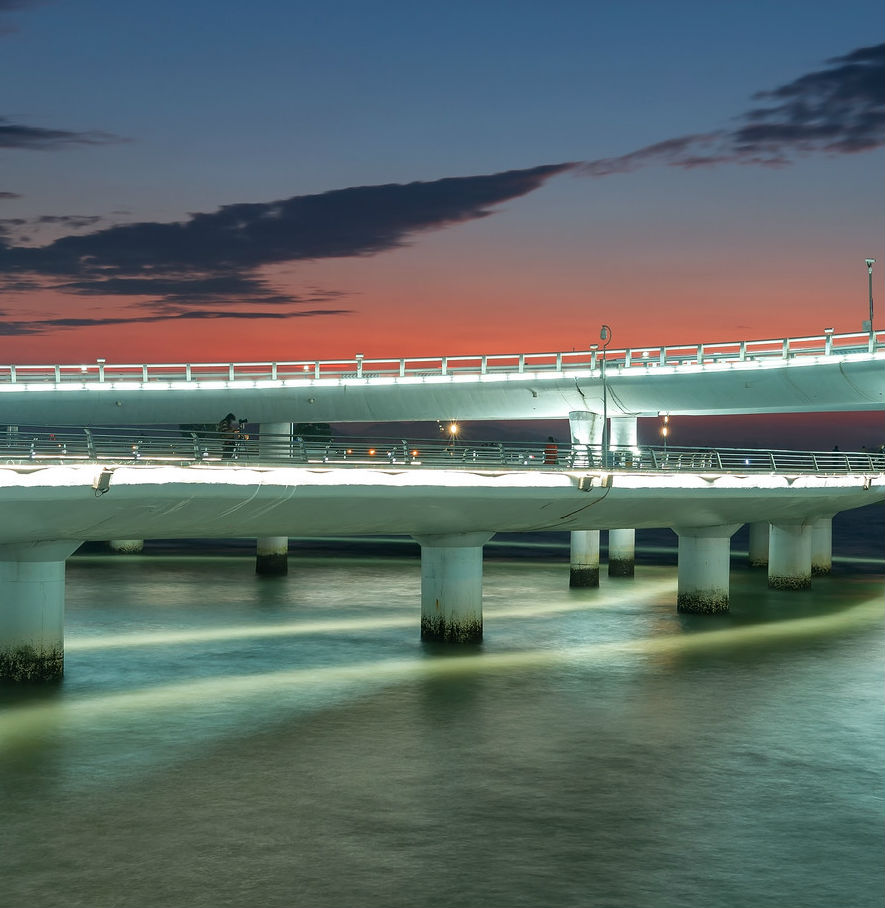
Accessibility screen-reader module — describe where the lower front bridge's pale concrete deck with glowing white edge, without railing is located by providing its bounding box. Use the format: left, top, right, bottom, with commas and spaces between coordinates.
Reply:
0, 465, 885, 545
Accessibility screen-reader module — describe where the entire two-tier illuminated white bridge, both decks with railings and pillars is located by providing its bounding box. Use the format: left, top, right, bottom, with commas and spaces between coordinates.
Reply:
0, 331, 885, 678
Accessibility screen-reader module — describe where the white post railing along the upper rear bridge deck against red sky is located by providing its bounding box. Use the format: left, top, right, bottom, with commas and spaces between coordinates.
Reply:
0, 331, 885, 386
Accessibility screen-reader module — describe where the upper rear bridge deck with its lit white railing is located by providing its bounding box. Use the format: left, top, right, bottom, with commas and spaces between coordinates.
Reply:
0, 332, 885, 425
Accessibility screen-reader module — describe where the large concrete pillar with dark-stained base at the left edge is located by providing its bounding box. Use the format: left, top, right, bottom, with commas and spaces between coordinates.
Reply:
0, 540, 80, 681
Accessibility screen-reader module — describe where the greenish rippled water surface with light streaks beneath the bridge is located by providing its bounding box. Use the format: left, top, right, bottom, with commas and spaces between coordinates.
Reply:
0, 510, 885, 908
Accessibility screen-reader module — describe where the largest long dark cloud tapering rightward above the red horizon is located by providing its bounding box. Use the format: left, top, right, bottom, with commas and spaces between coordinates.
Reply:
0, 164, 574, 320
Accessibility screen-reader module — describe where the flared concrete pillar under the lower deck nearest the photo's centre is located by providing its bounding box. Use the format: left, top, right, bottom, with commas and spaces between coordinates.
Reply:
415, 533, 494, 643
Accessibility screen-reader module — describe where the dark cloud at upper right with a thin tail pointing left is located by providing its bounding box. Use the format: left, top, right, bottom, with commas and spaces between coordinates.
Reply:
581, 44, 885, 176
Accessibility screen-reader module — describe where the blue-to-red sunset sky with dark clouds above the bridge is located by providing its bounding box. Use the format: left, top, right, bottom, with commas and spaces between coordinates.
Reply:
0, 0, 885, 364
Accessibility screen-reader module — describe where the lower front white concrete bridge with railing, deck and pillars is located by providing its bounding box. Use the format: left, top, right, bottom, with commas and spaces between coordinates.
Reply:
0, 430, 885, 679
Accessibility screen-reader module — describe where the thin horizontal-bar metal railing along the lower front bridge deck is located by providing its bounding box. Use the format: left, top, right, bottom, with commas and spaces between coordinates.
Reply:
0, 427, 885, 475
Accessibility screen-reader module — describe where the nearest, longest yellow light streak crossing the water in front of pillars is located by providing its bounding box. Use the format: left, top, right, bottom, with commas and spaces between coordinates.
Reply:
0, 597, 882, 754
